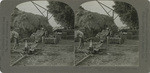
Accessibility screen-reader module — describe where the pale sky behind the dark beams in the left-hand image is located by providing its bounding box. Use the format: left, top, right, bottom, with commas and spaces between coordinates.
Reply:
17, 1, 60, 27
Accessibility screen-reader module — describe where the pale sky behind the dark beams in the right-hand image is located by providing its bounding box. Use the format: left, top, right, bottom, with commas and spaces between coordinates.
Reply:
81, 1, 125, 27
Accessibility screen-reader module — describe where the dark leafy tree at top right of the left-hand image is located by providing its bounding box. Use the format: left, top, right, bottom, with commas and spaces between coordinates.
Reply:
47, 1, 74, 28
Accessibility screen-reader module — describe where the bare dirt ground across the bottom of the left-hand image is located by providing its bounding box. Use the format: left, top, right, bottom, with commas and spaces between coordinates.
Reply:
11, 40, 75, 66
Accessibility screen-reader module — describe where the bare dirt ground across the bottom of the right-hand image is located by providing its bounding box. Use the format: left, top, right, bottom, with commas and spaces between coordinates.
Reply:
75, 40, 139, 66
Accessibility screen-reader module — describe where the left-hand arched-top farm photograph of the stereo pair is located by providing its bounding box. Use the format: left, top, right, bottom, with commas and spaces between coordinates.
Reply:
10, 1, 75, 66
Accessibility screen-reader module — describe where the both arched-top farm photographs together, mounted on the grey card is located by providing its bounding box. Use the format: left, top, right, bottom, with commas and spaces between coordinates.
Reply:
10, 0, 139, 66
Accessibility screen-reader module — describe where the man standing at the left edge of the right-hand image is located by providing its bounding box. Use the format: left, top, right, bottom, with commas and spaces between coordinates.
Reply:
74, 26, 84, 49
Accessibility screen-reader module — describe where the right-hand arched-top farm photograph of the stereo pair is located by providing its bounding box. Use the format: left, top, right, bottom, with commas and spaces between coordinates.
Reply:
74, 0, 139, 66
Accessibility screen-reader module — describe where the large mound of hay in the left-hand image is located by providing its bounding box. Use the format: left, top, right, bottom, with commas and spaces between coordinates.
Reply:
11, 8, 52, 37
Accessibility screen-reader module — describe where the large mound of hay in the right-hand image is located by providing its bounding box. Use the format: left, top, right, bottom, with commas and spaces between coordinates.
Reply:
75, 8, 118, 37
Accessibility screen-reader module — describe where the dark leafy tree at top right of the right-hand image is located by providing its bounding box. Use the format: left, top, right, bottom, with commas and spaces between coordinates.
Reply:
113, 1, 139, 29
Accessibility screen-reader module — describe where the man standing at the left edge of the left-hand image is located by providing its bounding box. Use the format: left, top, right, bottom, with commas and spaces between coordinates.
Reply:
10, 27, 19, 49
